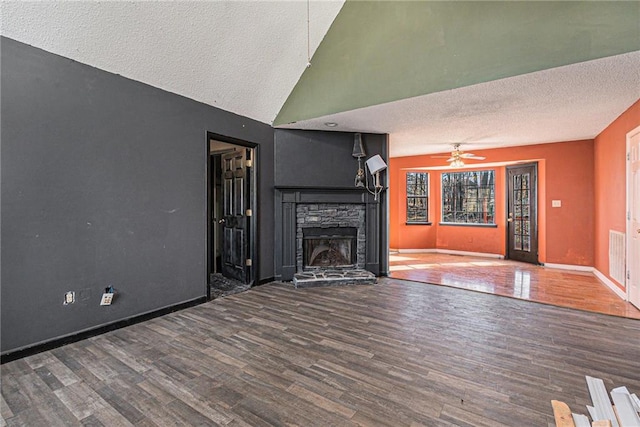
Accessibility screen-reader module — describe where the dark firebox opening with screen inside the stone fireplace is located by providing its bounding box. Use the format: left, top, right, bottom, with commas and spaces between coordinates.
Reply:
302, 227, 358, 268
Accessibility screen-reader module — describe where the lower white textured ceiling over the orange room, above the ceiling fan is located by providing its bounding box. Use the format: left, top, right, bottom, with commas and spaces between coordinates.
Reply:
283, 51, 640, 157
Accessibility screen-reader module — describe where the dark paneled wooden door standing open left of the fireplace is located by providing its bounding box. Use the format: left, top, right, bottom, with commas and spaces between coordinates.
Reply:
220, 148, 251, 283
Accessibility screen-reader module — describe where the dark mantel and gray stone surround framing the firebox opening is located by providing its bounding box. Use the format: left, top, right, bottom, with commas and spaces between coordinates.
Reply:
274, 187, 382, 285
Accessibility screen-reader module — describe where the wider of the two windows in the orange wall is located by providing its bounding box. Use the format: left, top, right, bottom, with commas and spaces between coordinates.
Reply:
439, 169, 498, 228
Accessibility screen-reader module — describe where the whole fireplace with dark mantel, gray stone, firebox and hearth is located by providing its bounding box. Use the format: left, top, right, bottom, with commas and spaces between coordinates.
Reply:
274, 187, 387, 287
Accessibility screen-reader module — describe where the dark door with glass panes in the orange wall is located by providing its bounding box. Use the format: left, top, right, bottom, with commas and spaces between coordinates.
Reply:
507, 164, 538, 264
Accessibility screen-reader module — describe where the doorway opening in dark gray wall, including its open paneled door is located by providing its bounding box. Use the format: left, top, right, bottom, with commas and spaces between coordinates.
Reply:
207, 133, 258, 299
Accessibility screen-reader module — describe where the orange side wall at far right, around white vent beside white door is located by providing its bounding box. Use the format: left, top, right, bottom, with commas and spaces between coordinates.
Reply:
594, 100, 640, 289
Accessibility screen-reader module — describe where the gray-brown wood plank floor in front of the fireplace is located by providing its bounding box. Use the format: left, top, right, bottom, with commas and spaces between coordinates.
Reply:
0, 279, 640, 427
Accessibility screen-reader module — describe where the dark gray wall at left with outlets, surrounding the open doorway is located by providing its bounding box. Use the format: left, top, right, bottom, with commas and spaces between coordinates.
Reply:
0, 38, 275, 354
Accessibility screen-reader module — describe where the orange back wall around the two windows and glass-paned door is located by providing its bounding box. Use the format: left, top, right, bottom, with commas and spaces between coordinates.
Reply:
389, 140, 595, 266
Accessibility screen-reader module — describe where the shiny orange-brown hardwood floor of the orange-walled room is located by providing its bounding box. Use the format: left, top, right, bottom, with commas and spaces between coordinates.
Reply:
390, 253, 640, 319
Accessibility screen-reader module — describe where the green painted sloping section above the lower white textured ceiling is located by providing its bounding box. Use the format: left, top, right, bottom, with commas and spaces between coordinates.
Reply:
274, 1, 640, 125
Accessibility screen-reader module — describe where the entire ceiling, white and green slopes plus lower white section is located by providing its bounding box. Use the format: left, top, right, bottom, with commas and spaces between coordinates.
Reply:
1, 1, 640, 156
